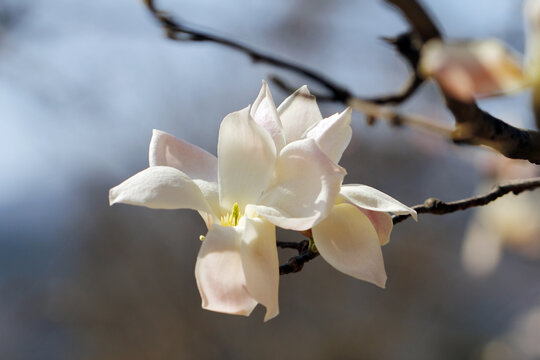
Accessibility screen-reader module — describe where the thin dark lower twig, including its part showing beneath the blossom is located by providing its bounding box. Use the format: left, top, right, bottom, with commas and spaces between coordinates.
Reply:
277, 177, 540, 275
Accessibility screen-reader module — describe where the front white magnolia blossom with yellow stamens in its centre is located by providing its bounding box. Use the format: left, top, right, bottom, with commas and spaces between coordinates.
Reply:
110, 85, 345, 321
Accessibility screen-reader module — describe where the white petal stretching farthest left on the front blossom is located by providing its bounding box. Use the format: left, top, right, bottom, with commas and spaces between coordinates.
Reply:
109, 166, 212, 213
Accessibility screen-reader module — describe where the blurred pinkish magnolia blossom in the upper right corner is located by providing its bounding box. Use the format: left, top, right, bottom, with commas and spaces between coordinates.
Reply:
419, 0, 540, 102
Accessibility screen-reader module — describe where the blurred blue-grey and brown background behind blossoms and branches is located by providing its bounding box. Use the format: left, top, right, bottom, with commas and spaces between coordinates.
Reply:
0, 0, 540, 360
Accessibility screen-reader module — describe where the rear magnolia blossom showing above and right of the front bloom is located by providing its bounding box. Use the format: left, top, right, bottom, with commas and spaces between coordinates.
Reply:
252, 83, 416, 287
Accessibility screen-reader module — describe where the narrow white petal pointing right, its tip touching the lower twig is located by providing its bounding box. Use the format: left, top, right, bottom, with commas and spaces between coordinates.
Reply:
339, 184, 418, 221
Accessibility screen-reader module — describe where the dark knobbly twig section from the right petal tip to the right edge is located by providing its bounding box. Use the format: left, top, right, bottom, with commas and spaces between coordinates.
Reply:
392, 177, 540, 224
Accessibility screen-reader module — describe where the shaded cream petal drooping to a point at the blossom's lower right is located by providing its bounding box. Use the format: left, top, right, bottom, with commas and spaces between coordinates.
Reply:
312, 204, 386, 288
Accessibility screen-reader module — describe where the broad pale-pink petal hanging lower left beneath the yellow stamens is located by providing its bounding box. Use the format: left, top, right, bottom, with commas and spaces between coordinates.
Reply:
195, 224, 257, 316
